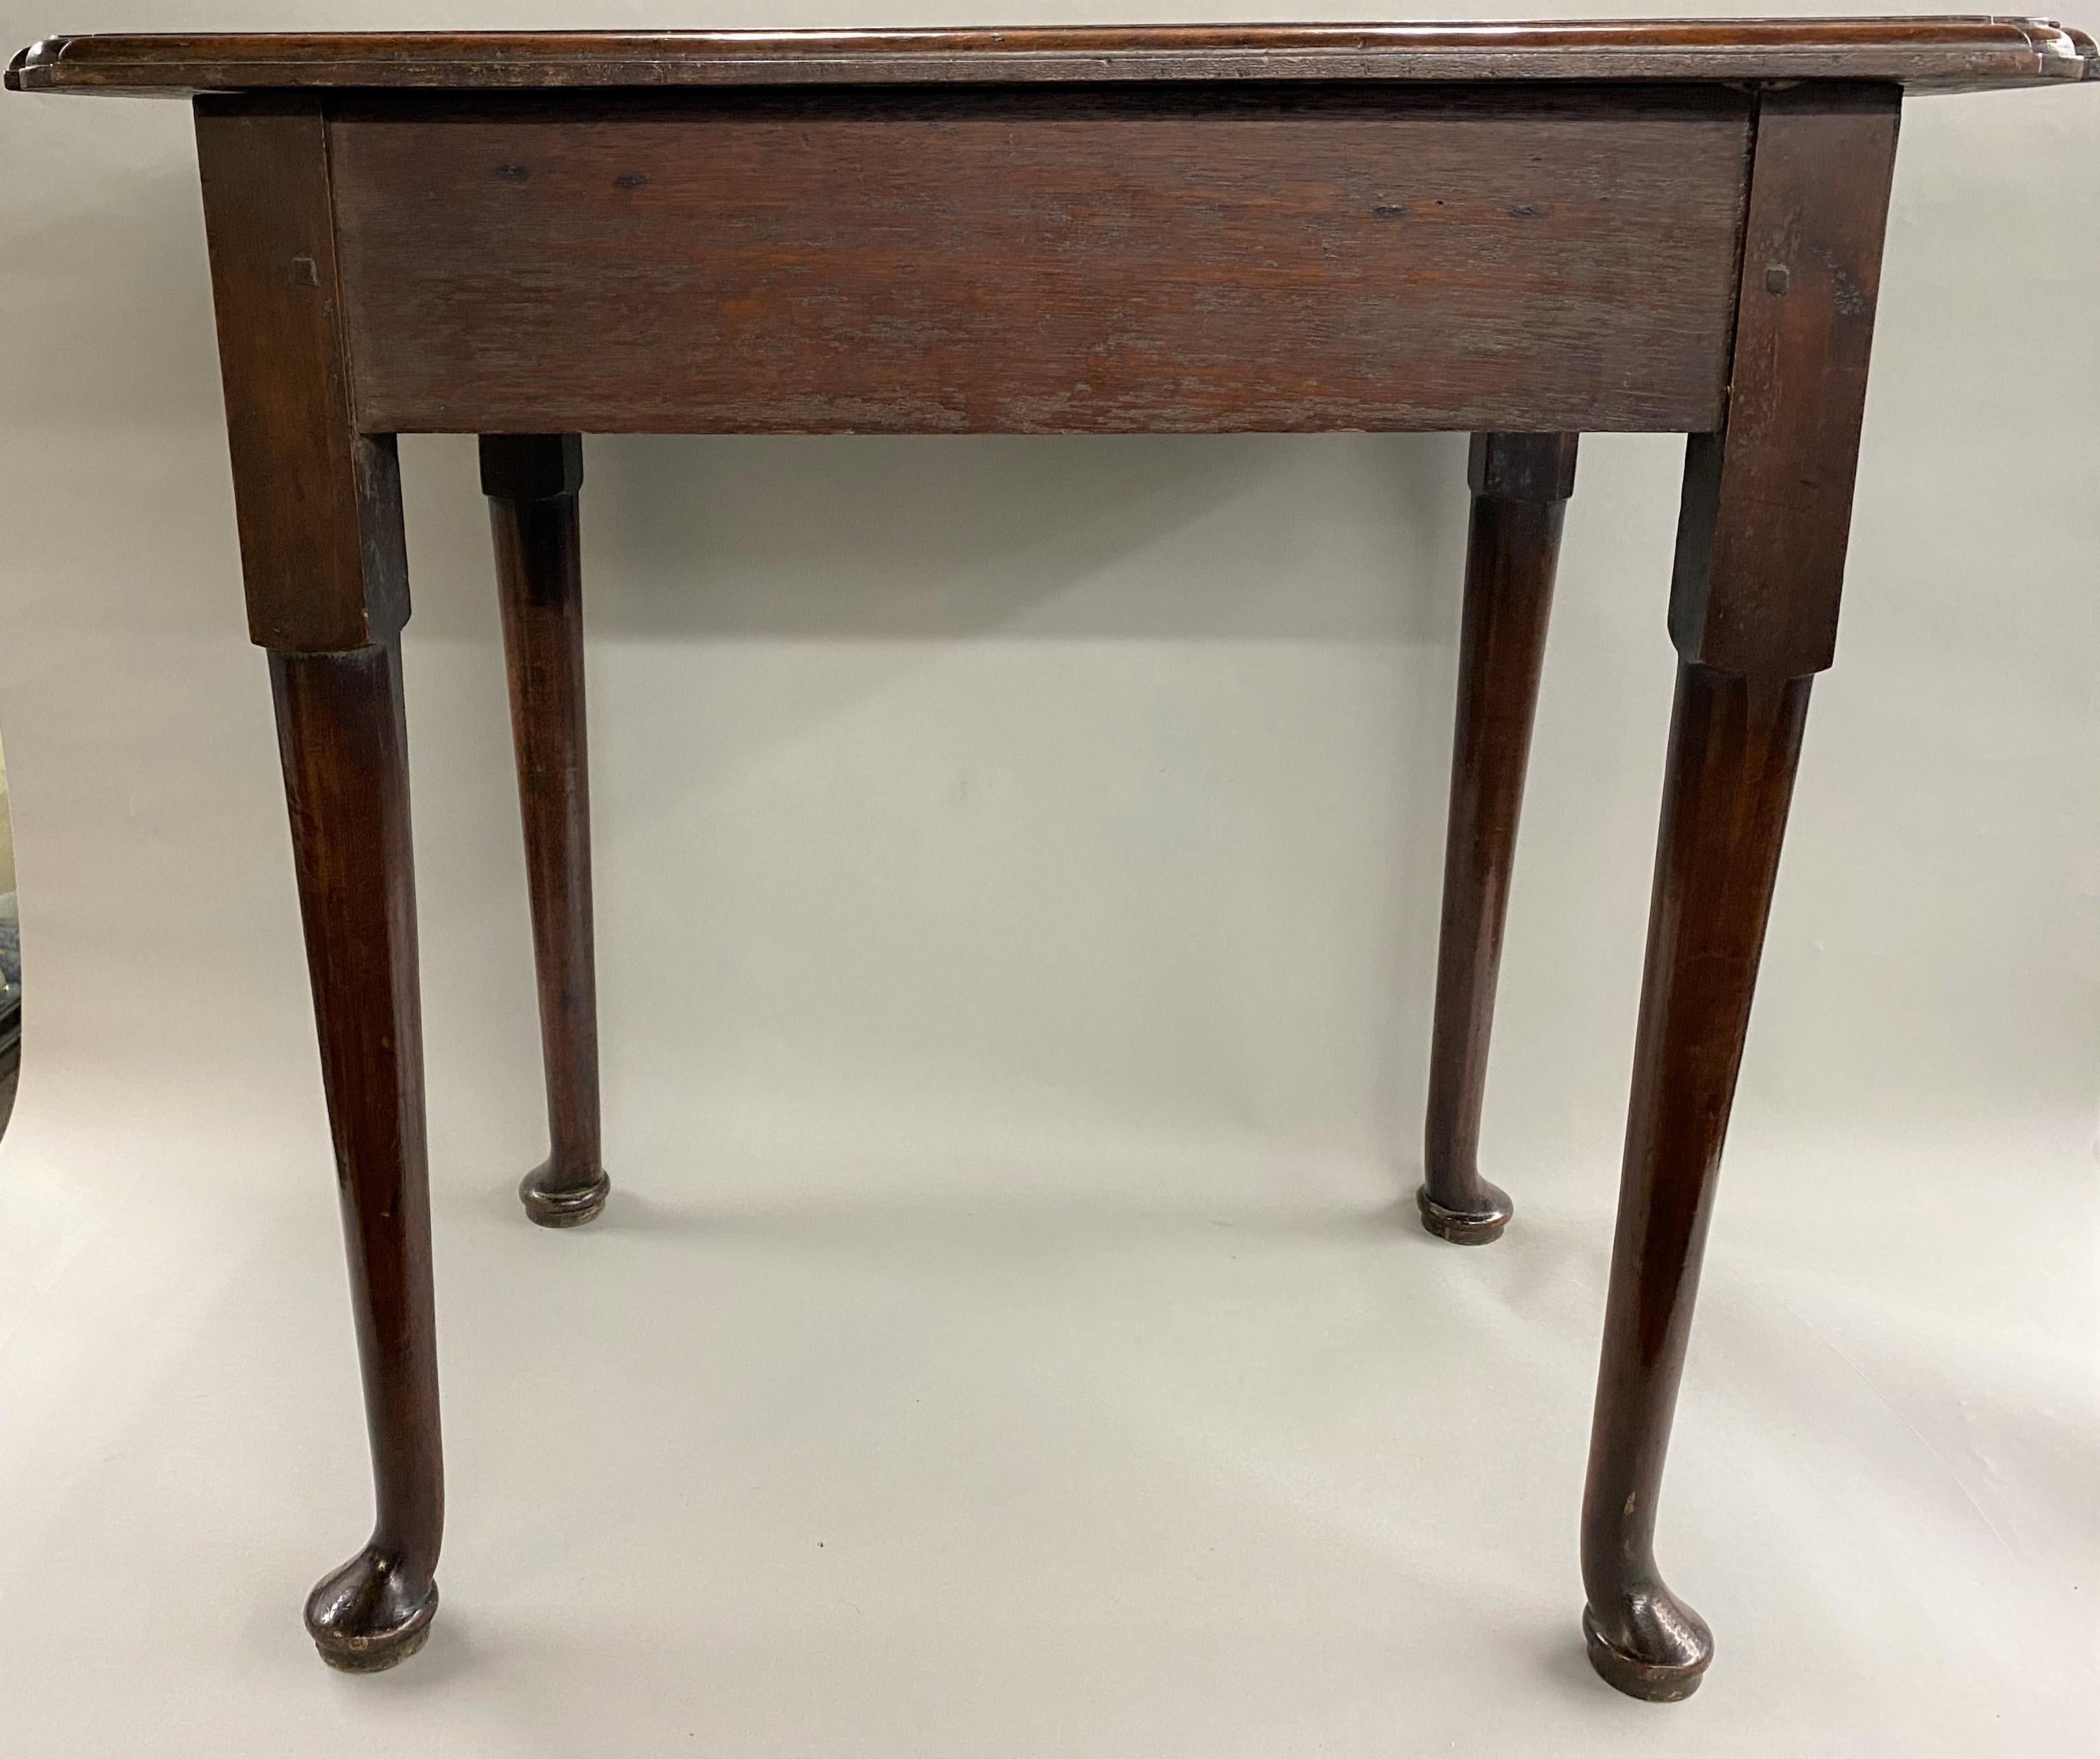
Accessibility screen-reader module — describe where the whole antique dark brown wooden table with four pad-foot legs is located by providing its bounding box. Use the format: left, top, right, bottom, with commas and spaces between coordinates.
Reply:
6, 17, 2100, 1698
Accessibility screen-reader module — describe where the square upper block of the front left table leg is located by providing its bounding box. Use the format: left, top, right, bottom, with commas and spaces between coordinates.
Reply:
197, 97, 408, 653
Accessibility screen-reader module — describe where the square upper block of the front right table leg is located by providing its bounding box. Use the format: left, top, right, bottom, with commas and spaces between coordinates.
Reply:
1669, 86, 1901, 678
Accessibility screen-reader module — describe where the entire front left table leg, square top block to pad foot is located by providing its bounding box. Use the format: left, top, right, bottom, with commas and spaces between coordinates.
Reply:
195, 92, 445, 1671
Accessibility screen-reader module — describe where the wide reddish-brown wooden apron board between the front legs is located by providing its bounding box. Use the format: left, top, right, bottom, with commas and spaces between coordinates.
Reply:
329, 88, 1749, 432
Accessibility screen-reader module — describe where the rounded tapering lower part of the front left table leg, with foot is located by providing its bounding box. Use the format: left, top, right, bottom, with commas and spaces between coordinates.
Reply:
268, 638, 445, 1673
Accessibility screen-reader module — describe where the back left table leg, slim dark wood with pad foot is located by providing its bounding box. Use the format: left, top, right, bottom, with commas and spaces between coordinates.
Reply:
481, 434, 611, 1228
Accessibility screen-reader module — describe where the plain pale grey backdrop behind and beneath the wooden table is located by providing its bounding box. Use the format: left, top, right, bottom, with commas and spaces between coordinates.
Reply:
0, 0, 2100, 1759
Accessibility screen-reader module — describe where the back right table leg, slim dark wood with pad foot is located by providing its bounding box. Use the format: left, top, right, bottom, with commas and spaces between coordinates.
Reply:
1415, 434, 1577, 1245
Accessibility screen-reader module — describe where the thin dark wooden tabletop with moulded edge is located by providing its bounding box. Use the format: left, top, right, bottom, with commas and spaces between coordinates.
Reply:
6, 17, 2096, 95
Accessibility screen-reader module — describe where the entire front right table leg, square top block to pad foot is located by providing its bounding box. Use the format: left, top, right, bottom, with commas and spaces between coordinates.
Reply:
1584, 86, 1899, 1698
